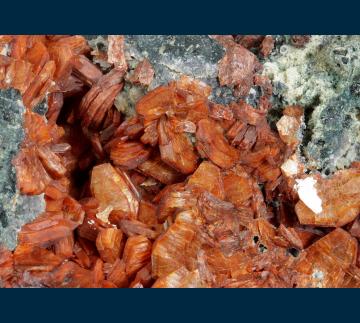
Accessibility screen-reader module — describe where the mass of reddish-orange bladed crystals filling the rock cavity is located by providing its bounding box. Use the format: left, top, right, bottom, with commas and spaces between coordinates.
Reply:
0, 36, 360, 288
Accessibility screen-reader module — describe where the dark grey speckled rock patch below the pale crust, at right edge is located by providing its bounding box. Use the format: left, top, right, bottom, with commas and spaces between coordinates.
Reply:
303, 90, 360, 175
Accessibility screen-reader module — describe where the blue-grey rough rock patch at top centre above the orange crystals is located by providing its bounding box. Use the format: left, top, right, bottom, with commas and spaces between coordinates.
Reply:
126, 35, 224, 88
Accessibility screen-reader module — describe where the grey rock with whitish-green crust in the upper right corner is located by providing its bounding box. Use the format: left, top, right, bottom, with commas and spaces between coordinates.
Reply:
264, 36, 360, 175
